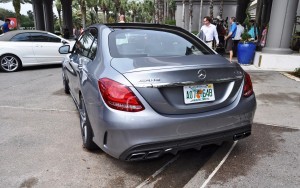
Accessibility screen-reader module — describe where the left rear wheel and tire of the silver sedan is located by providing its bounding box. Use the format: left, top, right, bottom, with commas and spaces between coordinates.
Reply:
79, 96, 98, 150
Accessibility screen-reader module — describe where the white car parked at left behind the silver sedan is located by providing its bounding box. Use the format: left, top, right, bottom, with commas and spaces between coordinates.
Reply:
0, 30, 74, 72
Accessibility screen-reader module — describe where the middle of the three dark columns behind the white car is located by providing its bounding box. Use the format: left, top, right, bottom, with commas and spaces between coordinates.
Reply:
43, 0, 54, 33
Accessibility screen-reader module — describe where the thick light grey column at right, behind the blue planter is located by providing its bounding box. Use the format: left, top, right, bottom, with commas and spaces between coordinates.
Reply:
262, 0, 299, 54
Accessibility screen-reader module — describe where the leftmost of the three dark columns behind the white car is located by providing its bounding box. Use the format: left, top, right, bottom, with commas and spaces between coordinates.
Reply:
32, 0, 45, 31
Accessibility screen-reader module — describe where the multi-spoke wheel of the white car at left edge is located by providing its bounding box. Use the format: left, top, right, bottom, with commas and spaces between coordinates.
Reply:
0, 54, 22, 72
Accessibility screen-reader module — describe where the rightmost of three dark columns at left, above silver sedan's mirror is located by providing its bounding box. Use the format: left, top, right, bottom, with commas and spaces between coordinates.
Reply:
61, 0, 73, 38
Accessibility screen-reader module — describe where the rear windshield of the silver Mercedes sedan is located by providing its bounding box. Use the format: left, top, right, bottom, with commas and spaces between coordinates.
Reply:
109, 29, 212, 57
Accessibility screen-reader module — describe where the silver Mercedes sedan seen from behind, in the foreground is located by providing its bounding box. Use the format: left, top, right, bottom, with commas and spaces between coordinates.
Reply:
59, 23, 256, 161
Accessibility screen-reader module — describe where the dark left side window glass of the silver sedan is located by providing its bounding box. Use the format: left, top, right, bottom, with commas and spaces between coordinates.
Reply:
74, 28, 98, 59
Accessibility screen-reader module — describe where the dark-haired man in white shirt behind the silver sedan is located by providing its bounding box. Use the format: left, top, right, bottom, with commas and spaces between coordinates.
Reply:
200, 16, 219, 48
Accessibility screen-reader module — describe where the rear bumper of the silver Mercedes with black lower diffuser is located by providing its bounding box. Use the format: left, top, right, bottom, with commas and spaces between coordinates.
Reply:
89, 92, 256, 160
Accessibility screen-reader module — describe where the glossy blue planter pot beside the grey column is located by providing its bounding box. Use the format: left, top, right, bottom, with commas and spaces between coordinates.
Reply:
237, 42, 256, 65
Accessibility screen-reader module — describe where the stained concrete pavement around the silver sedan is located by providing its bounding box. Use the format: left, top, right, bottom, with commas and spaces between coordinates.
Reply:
0, 66, 300, 188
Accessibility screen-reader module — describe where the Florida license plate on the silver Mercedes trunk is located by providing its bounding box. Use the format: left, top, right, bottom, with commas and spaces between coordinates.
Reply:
183, 84, 215, 104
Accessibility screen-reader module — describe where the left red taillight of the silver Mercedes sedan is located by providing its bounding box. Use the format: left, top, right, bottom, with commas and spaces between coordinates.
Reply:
98, 78, 145, 112
